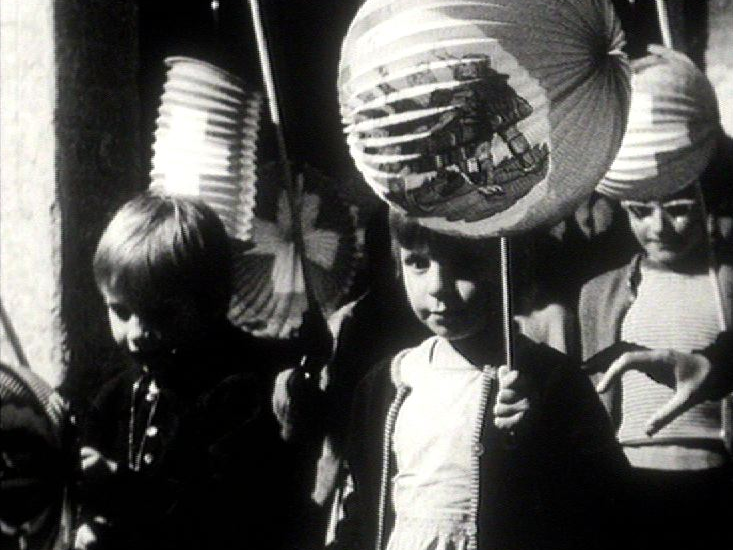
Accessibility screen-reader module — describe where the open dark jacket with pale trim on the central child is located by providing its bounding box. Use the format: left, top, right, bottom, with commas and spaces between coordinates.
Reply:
334, 336, 628, 550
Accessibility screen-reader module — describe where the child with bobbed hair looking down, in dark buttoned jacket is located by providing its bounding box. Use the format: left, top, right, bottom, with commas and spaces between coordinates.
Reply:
76, 192, 282, 550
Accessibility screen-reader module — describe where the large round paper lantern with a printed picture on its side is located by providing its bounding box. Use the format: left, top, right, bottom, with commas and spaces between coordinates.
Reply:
338, 0, 629, 237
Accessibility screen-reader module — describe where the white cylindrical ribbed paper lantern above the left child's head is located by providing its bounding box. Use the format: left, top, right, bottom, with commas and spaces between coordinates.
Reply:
151, 57, 265, 244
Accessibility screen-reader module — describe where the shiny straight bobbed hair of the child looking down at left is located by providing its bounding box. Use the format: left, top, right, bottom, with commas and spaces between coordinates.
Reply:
94, 191, 232, 319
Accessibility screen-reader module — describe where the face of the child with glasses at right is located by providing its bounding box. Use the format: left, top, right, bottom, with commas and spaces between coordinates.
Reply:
622, 191, 705, 267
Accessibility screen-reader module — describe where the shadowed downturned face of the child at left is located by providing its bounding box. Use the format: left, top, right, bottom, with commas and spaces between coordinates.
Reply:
101, 287, 203, 368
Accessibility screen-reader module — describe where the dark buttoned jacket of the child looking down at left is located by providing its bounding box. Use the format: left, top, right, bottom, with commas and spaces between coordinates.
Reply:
82, 328, 287, 550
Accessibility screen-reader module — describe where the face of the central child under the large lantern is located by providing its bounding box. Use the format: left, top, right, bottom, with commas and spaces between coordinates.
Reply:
400, 243, 500, 340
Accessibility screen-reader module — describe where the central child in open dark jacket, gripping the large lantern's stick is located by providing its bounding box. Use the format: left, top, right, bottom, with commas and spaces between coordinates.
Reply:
334, 212, 626, 550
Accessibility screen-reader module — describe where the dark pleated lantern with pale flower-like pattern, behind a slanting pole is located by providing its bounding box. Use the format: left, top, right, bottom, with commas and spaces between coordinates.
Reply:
229, 163, 356, 339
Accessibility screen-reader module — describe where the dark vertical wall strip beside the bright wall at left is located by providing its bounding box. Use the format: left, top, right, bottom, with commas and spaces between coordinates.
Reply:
54, 0, 144, 404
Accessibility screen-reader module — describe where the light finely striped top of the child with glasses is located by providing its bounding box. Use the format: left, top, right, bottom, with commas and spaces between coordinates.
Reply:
619, 266, 721, 463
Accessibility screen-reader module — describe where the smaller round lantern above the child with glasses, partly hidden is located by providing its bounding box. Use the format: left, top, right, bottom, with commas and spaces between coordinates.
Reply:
597, 46, 720, 200
